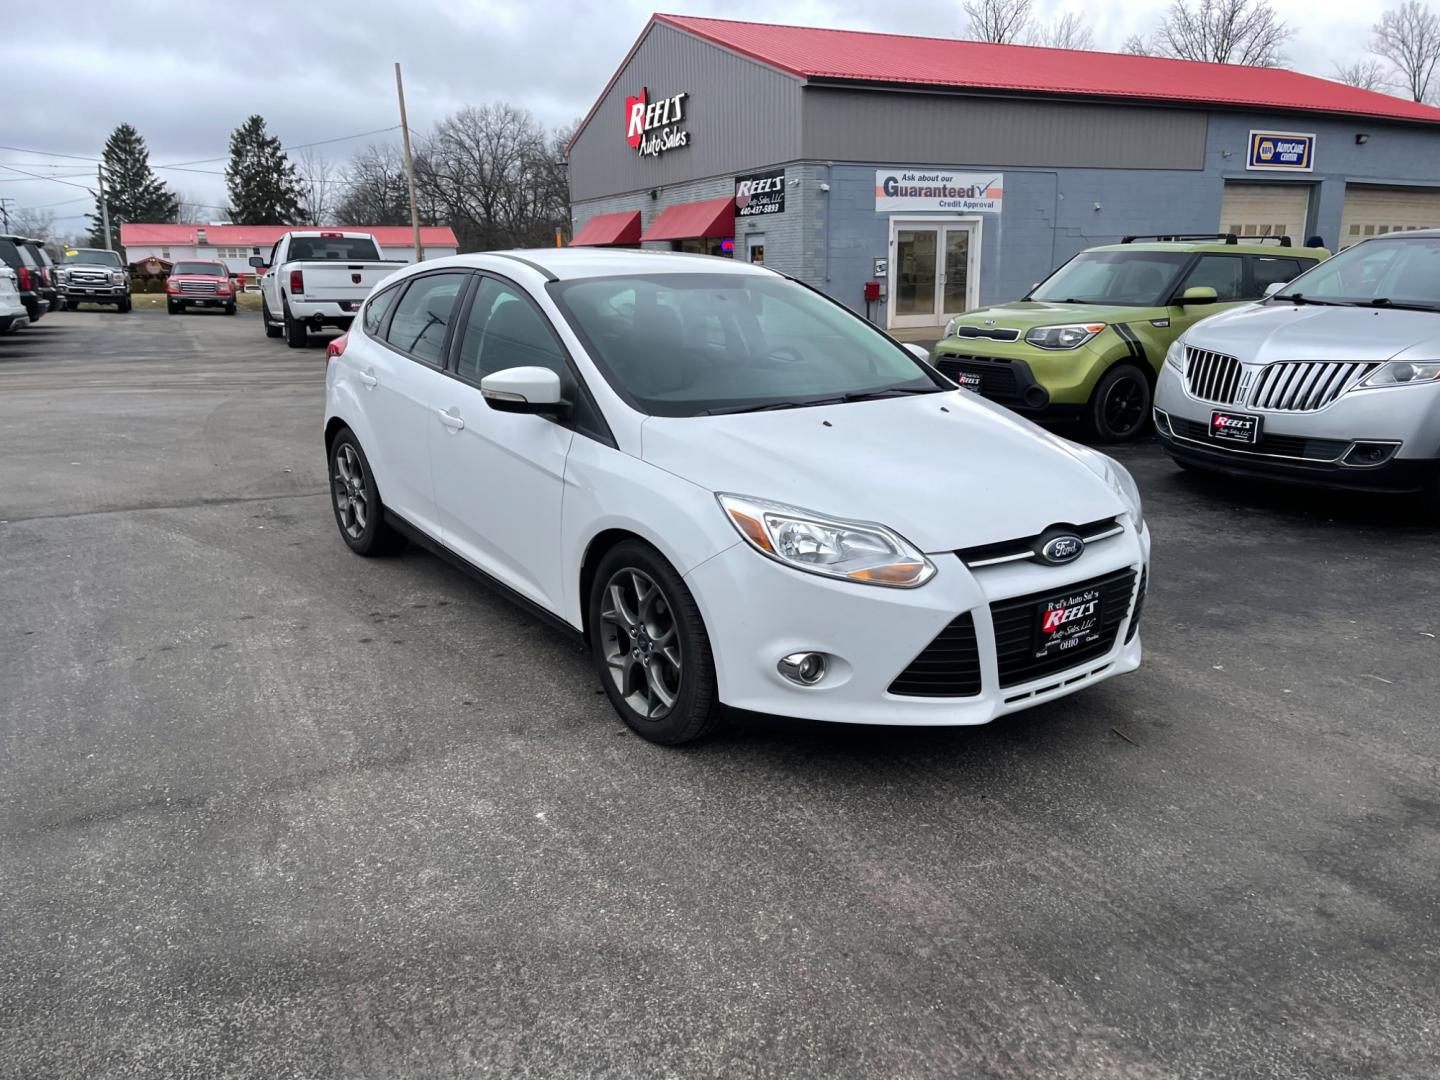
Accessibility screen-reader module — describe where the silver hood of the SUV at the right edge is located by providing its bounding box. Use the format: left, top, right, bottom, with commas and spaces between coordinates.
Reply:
1184, 302, 1440, 363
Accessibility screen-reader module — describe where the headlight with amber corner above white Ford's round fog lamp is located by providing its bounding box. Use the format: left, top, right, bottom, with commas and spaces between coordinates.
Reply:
716, 492, 935, 589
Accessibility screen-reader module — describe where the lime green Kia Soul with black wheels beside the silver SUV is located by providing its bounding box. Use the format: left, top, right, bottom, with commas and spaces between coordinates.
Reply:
932, 233, 1331, 442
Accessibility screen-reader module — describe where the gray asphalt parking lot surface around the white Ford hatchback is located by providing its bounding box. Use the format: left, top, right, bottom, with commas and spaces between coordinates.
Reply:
0, 312, 1440, 1080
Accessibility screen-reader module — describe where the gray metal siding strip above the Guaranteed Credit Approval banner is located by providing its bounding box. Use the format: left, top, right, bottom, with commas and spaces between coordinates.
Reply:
802, 86, 1207, 168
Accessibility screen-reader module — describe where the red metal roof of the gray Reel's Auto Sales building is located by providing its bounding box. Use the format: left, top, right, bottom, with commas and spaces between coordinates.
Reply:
656, 14, 1440, 124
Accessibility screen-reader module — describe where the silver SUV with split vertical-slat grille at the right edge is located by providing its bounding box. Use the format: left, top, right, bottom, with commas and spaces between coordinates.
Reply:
1155, 229, 1440, 513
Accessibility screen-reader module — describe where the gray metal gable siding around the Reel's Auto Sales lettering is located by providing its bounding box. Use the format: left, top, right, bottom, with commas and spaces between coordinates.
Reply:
570, 23, 801, 202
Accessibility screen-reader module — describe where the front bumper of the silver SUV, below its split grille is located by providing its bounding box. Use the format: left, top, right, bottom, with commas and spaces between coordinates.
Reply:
1155, 364, 1440, 492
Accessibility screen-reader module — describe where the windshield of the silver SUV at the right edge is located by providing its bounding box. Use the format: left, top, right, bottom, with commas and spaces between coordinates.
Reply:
1279, 235, 1440, 310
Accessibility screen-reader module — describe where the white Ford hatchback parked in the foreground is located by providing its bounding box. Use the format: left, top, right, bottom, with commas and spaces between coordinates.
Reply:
325, 249, 1149, 743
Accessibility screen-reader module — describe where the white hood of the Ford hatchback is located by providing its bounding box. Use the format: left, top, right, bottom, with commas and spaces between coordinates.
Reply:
641, 390, 1126, 552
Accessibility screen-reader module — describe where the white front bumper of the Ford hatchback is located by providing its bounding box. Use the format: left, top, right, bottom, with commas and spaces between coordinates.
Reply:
685, 527, 1151, 726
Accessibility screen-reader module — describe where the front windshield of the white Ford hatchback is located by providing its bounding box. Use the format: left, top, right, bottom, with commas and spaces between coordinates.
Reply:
550, 274, 945, 416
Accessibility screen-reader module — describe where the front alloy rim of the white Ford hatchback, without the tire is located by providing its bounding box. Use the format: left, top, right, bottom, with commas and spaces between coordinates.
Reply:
600, 567, 684, 720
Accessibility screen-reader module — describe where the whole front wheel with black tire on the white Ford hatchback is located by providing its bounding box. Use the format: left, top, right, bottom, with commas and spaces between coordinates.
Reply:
589, 540, 721, 746
